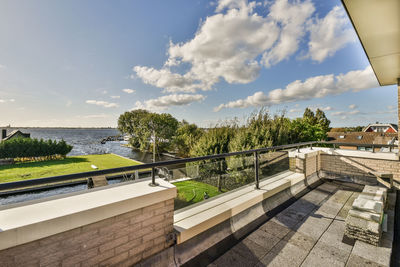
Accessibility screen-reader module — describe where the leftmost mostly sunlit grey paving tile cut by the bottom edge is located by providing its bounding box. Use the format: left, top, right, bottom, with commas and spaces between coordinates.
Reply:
256, 240, 308, 267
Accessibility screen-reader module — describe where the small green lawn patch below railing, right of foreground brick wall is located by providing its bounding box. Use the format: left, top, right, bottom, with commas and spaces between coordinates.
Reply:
174, 180, 223, 210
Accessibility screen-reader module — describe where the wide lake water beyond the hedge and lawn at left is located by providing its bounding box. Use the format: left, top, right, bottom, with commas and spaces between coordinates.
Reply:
3, 128, 170, 163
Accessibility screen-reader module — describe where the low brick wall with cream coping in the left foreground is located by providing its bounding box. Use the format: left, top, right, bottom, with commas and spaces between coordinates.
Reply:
0, 180, 176, 266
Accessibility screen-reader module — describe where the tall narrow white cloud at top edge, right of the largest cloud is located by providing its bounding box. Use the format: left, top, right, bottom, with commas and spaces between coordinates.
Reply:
262, 0, 315, 67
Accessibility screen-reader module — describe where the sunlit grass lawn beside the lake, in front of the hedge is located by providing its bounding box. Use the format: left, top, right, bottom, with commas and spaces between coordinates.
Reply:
0, 154, 141, 183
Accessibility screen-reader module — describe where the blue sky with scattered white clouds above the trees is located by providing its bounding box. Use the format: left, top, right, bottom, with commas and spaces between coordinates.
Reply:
0, 0, 397, 127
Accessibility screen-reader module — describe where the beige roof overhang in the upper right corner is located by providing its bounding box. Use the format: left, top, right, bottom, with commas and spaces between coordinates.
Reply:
342, 0, 400, 85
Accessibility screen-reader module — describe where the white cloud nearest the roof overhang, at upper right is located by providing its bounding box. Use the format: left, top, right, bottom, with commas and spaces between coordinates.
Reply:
308, 6, 356, 62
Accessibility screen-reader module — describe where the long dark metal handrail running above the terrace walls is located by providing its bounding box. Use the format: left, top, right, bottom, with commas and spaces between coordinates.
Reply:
0, 141, 397, 190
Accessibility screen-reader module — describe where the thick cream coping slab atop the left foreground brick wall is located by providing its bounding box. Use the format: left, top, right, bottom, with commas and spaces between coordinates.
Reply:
0, 179, 177, 250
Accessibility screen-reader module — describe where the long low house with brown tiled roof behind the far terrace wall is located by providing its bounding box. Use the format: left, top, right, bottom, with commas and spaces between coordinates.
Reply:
327, 132, 397, 152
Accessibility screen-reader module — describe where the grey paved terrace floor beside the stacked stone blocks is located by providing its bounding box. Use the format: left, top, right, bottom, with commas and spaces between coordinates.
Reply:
209, 183, 391, 267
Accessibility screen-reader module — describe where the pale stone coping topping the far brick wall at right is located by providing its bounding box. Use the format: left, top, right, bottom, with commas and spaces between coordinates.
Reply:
289, 147, 399, 161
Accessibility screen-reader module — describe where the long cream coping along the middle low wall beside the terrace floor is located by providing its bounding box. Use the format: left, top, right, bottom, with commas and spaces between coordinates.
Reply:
174, 171, 304, 244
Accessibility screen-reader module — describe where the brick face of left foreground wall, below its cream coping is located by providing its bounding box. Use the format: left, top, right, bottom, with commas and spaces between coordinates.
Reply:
0, 199, 174, 266
